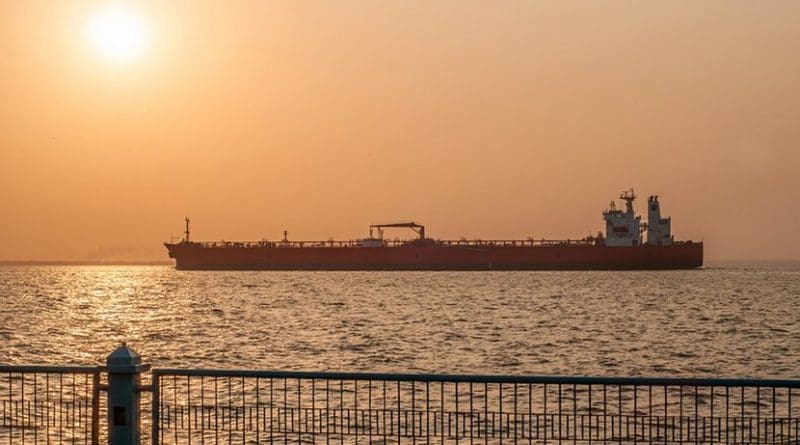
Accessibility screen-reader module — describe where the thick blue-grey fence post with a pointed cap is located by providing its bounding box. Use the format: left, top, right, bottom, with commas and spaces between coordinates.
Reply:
106, 343, 150, 445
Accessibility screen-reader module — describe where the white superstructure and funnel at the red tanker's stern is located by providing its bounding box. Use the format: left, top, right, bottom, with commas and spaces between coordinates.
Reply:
603, 189, 673, 247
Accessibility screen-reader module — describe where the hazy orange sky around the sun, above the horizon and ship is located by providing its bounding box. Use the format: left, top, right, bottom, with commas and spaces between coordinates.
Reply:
0, 0, 800, 260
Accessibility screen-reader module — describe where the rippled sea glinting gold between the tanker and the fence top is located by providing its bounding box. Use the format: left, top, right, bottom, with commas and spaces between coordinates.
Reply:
0, 266, 800, 378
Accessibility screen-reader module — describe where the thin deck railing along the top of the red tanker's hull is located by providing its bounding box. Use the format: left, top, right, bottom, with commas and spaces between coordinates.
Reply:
186, 238, 595, 248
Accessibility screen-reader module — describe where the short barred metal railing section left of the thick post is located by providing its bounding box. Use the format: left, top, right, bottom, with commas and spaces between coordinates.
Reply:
0, 365, 100, 445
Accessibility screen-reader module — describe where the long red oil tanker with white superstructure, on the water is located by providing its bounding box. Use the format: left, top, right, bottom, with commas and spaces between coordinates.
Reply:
164, 189, 703, 270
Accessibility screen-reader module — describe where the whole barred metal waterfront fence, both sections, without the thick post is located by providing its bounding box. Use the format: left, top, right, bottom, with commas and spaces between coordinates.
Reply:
0, 358, 800, 445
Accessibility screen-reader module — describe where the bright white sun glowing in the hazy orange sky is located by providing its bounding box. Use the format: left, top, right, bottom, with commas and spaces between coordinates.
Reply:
87, 6, 149, 63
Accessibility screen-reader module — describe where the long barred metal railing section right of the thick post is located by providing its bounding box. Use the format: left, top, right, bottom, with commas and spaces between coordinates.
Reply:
151, 369, 800, 445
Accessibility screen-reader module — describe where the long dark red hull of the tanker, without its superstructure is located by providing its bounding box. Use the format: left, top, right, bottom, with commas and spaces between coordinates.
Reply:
165, 242, 703, 270
